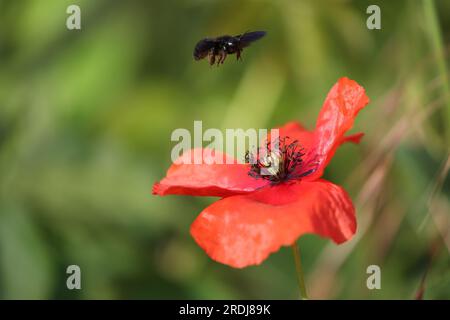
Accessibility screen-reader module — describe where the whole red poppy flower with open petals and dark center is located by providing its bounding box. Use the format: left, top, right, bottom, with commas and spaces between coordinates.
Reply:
153, 78, 369, 268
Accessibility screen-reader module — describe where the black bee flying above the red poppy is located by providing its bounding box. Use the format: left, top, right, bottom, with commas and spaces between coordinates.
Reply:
194, 31, 266, 66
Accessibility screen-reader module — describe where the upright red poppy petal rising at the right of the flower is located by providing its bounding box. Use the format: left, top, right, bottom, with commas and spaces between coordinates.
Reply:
305, 78, 369, 180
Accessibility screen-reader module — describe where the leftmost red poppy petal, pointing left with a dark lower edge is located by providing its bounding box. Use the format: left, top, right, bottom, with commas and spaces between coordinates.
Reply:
152, 149, 268, 197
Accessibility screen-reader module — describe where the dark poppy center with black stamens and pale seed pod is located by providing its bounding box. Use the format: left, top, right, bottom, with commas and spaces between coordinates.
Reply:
245, 137, 314, 183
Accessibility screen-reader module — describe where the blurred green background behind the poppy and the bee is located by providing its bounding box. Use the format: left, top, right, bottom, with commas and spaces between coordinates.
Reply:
0, 0, 450, 299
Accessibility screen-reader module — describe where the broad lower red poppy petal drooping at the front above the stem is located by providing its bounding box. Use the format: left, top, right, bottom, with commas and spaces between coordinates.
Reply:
191, 180, 356, 268
